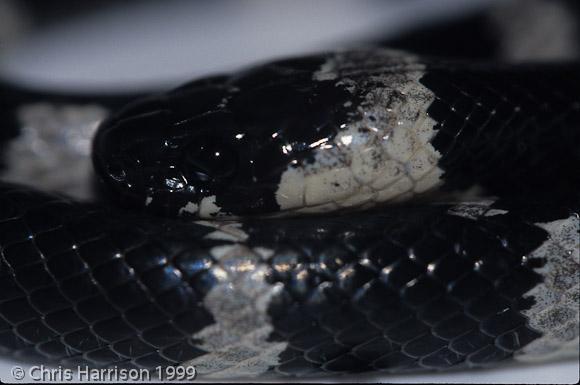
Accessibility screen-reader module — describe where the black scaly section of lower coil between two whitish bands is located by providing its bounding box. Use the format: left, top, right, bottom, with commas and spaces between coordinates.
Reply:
239, 202, 552, 375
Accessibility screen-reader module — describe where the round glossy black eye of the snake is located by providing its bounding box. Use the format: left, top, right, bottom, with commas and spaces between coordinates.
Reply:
183, 137, 237, 183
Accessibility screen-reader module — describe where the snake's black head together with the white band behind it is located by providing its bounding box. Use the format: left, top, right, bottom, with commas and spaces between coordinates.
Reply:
93, 52, 442, 218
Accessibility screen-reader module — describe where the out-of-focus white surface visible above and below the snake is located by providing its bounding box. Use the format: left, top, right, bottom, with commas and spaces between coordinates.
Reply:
0, 0, 579, 383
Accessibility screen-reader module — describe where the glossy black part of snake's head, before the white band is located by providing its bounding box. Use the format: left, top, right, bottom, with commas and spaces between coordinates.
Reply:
93, 54, 347, 217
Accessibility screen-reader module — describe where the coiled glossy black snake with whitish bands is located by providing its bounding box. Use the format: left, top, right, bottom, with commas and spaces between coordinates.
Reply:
0, 0, 580, 379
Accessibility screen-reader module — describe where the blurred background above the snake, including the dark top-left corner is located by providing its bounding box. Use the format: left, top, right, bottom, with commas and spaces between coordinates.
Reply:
0, 0, 501, 92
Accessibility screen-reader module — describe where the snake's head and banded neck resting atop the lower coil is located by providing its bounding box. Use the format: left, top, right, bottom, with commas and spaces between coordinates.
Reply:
94, 49, 580, 219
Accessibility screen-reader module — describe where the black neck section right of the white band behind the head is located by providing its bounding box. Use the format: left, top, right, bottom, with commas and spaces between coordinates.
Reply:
420, 65, 580, 197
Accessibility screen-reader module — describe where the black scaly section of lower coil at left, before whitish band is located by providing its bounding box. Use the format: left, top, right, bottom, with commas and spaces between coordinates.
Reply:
0, 186, 218, 367
